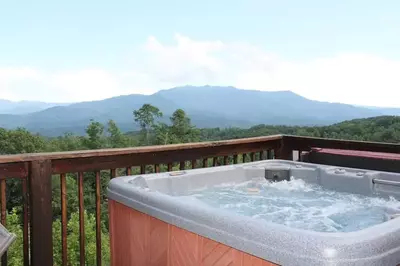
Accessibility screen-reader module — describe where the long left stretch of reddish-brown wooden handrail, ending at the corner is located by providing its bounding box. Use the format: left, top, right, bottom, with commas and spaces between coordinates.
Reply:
0, 135, 282, 177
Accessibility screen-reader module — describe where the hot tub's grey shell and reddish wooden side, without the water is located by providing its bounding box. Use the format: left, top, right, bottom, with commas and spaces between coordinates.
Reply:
108, 160, 400, 266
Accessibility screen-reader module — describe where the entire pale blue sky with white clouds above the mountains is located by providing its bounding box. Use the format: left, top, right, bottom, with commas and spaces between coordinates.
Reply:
0, 0, 400, 107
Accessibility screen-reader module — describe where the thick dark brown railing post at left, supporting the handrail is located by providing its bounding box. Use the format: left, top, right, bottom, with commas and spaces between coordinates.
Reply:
29, 160, 53, 266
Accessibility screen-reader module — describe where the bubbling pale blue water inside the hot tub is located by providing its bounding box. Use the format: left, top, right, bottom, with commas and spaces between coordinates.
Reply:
189, 177, 400, 232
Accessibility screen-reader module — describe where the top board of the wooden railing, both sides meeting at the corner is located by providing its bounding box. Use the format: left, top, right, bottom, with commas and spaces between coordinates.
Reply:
0, 135, 400, 166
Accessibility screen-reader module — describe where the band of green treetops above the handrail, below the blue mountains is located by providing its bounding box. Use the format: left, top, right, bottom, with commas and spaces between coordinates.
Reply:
0, 107, 400, 157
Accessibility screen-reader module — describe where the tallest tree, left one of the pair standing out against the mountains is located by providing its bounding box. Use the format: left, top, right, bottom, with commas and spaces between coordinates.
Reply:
133, 104, 163, 145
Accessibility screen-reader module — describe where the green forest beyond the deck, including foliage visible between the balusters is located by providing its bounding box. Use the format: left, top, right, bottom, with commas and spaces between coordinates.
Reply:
0, 104, 400, 265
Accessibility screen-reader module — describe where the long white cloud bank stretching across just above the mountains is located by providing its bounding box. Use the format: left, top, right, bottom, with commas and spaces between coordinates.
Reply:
0, 34, 400, 107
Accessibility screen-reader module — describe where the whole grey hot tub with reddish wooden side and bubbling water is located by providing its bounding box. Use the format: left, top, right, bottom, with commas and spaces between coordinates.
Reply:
108, 160, 400, 266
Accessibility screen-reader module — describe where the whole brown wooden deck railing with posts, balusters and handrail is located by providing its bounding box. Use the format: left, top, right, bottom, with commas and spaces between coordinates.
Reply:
0, 135, 400, 265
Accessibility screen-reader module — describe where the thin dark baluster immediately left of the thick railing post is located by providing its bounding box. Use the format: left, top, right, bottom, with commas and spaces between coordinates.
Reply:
22, 177, 30, 266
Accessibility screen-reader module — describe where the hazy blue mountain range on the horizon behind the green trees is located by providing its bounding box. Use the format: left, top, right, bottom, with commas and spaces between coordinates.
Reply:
0, 86, 400, 136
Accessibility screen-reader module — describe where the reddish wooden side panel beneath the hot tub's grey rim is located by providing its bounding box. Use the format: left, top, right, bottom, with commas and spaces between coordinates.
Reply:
109, 200, 277, 266
